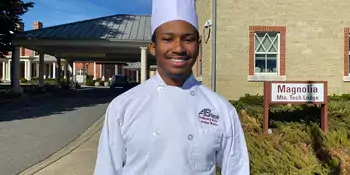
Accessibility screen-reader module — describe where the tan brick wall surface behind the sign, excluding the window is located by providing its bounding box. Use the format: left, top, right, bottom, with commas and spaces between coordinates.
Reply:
197, 0, 350, 99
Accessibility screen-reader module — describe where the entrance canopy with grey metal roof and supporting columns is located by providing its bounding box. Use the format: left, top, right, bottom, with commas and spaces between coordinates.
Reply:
7, 14, 155, 91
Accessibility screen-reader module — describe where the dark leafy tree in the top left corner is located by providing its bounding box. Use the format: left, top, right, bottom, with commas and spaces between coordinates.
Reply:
0, 0, 34, 58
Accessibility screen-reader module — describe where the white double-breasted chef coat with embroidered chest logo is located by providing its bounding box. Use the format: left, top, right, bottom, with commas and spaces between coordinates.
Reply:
95, 73, 250, 175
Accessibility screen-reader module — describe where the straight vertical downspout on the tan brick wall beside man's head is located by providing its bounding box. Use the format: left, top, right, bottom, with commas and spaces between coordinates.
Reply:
211, 0, 216, 92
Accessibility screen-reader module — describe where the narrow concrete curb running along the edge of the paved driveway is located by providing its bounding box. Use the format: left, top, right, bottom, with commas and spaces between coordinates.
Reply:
18, 115, 105, 175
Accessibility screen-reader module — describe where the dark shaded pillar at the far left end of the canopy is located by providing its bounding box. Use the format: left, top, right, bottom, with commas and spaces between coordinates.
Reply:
11, 46, 23, 93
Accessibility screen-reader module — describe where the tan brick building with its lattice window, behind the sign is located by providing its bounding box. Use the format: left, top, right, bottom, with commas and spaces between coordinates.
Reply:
195, 0, 350, 99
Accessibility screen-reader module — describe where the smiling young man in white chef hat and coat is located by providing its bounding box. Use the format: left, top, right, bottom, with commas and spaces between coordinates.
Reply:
95, 0, 250, 175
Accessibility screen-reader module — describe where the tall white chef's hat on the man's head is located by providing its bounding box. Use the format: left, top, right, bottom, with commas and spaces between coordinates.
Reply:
151, 0, 198, 35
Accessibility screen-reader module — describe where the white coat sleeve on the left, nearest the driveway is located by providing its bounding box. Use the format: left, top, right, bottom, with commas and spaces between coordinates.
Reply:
94, 102, 126, 175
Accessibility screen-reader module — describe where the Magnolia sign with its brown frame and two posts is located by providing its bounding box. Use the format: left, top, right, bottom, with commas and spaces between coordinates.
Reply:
263, 81, 328, 133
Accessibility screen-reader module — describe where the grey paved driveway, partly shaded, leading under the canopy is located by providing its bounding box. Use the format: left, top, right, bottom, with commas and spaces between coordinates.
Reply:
0, 88, 125, 175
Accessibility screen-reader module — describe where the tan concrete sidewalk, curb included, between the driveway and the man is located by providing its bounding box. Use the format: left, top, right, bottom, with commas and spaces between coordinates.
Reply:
19, 116, 104, 175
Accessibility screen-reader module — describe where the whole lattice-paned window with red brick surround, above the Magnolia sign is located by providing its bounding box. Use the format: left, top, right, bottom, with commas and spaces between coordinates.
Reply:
248, 26, 286, 81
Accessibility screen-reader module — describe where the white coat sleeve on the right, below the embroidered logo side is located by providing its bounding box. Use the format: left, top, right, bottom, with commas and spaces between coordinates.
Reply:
217, 108, 250, 175
